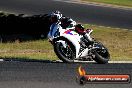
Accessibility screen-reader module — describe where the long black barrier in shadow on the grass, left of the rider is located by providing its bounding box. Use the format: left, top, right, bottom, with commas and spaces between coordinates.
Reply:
0, 12, 51, 42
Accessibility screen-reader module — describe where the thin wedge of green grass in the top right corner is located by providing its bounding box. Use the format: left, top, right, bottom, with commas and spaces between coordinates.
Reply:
82, 0, 132, 7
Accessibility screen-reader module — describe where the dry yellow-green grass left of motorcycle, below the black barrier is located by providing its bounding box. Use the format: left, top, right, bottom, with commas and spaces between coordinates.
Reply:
0, 39, 58, 60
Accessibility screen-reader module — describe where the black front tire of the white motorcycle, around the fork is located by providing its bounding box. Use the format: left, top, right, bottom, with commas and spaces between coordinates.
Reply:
54, 39, 75, 63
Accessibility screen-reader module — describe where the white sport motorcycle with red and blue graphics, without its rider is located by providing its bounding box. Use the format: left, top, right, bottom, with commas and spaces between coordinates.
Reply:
49, 24, 110, 64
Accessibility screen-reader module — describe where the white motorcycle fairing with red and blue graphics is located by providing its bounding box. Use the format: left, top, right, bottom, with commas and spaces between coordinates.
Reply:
50, 25, 88, 59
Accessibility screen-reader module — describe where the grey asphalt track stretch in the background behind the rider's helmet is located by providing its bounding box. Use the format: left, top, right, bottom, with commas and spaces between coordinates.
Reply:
0, 0, 132, 29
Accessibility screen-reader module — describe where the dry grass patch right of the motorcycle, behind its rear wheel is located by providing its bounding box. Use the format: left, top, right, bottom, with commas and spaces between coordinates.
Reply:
86, 25, 132, 61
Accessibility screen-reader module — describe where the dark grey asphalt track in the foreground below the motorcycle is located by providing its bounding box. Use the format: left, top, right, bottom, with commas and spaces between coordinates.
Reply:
0, 62, 132, 88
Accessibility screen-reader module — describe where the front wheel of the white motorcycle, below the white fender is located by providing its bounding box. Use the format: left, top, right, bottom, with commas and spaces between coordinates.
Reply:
54, 41, 75, 63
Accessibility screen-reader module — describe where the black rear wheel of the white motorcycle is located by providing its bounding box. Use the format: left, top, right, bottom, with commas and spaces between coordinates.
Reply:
93, 42, 110, 64
